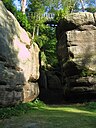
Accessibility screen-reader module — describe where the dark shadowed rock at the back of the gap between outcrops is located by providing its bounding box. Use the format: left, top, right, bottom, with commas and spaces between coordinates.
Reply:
39, 70, 63, 104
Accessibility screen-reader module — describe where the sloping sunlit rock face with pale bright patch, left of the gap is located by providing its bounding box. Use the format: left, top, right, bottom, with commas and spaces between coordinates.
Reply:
0, 1, 39, 106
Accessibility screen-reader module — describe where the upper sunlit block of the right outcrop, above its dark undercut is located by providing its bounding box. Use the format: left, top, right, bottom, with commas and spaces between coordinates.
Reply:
57, 12, 96, 70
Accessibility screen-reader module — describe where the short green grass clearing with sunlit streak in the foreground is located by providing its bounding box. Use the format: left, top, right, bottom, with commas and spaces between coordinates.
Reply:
0, 104, 96, 128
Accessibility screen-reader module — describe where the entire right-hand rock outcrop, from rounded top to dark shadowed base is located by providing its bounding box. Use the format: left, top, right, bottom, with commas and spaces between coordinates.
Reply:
56, 12, 96, 102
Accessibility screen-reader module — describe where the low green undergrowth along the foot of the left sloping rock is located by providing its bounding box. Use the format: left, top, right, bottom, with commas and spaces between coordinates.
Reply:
0, 99, 46, 119
